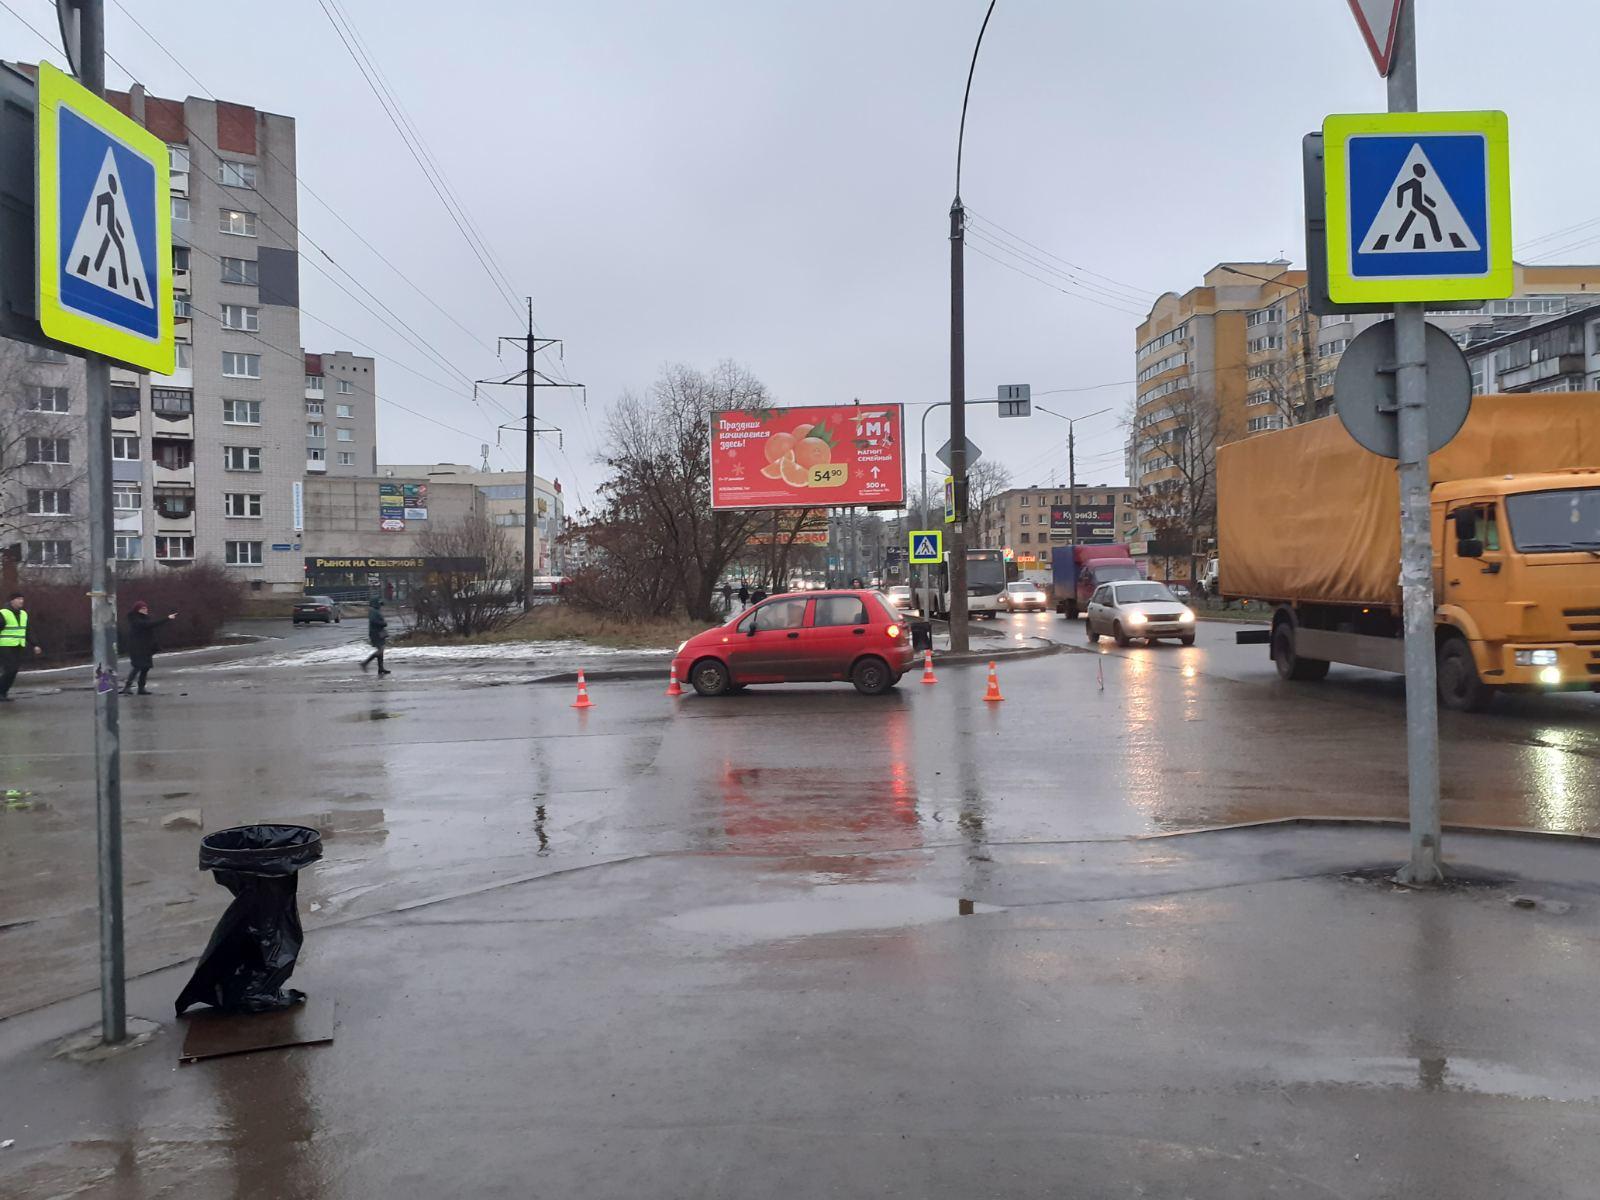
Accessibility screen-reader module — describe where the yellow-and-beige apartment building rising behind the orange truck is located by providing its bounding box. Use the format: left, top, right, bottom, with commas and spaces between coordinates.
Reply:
1126, 261, 1600, 579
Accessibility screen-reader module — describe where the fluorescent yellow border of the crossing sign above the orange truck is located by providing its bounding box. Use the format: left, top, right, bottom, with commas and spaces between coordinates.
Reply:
1322, 110, 1517, 304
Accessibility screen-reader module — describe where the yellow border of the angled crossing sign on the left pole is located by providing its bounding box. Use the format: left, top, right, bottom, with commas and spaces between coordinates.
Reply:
34, 62, 178, 374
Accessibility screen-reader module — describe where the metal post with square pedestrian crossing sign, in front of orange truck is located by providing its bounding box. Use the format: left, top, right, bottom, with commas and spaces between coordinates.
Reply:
1323, 0, 1514, 885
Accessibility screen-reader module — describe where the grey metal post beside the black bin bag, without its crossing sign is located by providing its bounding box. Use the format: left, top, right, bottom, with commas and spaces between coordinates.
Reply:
57, 0, 128, 1045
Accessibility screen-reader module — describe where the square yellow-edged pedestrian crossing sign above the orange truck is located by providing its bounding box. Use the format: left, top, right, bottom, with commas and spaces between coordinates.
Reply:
1322, 112, 1515, 304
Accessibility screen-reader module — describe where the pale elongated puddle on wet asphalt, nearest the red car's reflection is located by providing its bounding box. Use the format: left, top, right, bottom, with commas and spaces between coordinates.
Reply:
667, 883, 1005, 941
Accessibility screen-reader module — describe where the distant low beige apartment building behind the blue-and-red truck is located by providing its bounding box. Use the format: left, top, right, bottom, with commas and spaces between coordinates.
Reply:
974, 483, 1139, 571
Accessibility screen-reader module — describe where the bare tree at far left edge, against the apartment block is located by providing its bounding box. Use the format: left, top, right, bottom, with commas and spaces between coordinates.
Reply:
0, 341, 88, 560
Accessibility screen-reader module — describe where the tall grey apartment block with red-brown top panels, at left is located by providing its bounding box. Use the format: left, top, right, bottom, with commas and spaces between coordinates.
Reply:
0, 86, 378, 590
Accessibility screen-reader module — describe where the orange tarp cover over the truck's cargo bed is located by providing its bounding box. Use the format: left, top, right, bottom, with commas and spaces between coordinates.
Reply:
1216, 392, 1600, 606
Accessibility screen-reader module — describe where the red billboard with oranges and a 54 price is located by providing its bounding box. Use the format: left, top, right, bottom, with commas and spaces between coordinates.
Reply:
710, 405, 906, 509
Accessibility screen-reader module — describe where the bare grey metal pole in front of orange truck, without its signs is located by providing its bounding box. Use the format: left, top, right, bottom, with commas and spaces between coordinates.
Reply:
1389, 3, 1443, 883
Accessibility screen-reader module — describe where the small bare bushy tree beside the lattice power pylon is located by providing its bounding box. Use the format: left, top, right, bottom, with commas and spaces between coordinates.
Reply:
413, 514, 522, 637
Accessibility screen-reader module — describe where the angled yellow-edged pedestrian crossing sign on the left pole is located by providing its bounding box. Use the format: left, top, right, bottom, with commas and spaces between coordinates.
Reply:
35, 62, 174, 374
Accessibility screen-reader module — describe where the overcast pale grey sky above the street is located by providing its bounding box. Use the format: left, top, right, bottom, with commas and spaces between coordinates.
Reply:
9, 0, 1600, 499
